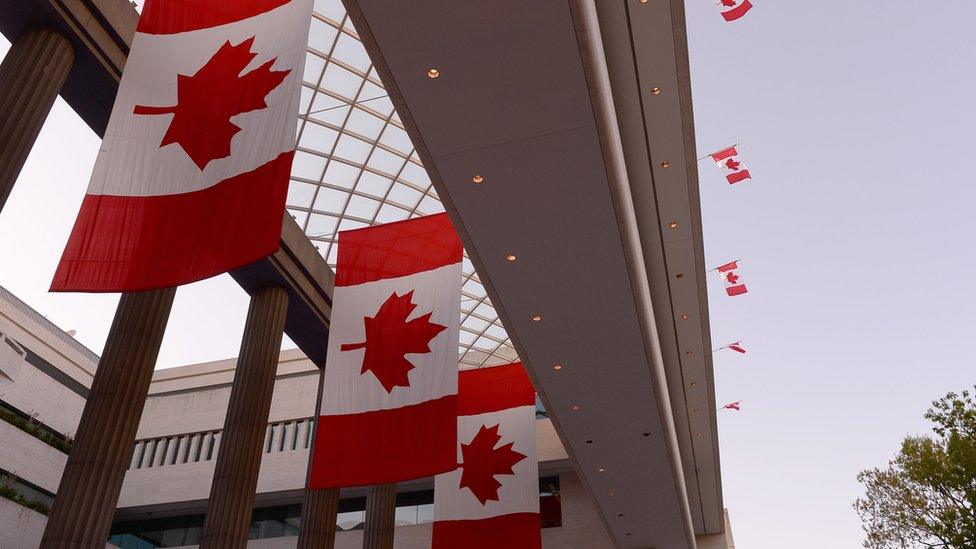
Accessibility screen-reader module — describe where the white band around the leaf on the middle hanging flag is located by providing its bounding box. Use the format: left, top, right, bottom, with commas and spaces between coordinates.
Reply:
320, 263, 461, 415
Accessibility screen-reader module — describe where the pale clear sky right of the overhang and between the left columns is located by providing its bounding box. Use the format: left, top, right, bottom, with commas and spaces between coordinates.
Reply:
0, 4, 976, 549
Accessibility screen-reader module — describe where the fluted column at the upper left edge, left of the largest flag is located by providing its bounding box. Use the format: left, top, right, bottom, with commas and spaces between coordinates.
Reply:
0, 28, 75, 210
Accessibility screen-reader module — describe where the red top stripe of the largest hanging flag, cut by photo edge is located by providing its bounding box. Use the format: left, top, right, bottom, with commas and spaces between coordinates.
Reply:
136, 0, 291, 34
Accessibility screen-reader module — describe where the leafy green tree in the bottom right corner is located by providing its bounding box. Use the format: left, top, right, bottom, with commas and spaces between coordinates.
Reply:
854, 391, 976, 549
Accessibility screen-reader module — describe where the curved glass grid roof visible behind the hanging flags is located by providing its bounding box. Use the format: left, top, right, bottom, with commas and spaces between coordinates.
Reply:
288, 0, 518, 368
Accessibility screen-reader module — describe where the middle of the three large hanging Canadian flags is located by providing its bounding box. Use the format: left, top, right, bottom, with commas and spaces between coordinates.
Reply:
309, 214, 462, 489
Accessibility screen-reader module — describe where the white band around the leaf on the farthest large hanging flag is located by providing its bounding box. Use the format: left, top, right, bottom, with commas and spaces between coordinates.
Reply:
434, 406, 539, 521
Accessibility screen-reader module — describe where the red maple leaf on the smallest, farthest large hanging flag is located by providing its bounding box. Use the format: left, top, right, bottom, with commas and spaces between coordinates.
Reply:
458, 425, 525, 505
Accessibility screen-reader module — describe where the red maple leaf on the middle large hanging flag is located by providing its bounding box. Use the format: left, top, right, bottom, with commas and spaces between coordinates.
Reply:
340, 290, 447, 393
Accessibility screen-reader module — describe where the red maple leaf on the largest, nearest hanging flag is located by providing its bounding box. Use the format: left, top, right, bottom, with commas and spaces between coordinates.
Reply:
132, 36, 291, 170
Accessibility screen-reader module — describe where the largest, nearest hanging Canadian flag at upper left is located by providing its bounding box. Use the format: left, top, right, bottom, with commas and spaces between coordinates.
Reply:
51, 0, 313, 292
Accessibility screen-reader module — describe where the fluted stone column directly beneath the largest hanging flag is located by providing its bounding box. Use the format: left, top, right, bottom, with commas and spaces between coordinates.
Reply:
41, 288, 176, 549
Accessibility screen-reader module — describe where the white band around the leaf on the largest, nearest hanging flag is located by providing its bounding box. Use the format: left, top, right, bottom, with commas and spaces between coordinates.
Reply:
88, 0, 311, 196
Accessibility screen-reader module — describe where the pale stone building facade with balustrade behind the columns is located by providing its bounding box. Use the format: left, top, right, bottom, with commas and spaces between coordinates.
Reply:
0, 288, 733, 549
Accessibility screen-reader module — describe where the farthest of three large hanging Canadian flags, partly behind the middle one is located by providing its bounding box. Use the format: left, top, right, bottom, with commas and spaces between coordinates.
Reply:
433, 364, 542, 549
